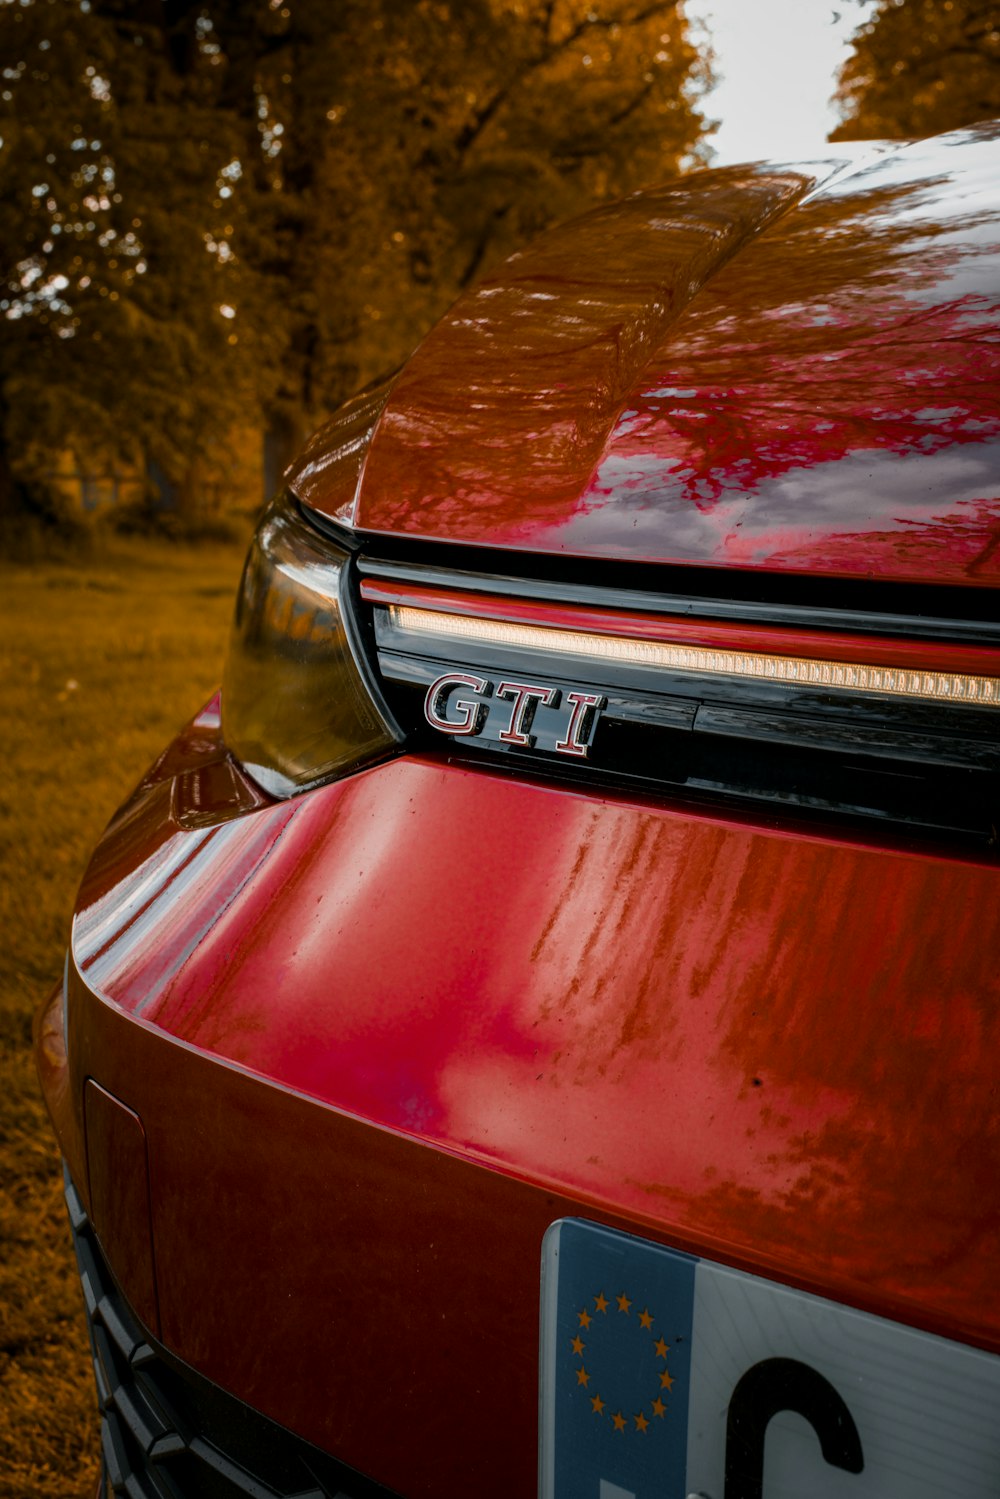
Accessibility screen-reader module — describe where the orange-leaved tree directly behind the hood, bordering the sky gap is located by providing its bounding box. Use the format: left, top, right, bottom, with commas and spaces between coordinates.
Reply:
247, 0, 708, 464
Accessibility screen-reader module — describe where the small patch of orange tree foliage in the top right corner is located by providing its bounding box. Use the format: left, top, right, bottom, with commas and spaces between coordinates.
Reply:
831, 0, 1000, 141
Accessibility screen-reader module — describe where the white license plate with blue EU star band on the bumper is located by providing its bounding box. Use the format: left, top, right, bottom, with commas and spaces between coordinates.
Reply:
540, 1219, 1000, 1499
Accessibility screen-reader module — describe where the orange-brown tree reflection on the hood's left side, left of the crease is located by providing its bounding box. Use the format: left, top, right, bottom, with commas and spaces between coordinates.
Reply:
358, 168, 804, 535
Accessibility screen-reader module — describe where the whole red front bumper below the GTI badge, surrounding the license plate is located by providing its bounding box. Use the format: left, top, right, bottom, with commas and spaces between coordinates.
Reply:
36, 712, 1000, 1499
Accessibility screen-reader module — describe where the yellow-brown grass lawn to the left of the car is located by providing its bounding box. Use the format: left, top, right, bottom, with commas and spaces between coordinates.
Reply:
0, 540, 244, 1499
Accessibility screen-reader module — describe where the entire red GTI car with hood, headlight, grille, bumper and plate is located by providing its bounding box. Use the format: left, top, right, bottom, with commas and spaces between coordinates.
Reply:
37, 126, 1000, 1499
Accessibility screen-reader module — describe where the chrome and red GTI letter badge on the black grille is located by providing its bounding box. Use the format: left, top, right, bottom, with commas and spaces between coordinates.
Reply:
424, 672, 607, 760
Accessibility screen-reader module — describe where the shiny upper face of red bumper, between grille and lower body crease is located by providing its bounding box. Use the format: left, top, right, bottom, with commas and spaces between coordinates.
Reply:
50, 701, 1000, 1348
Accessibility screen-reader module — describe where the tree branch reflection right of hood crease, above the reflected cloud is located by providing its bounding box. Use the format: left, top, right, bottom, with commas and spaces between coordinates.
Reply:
618, 183, 1000, 505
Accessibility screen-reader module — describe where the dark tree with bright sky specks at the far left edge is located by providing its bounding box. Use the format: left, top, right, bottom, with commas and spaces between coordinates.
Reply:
0, 0, 275, 527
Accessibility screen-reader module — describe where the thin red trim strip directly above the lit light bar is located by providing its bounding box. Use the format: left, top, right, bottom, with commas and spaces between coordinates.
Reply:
361, 579, 1000, 676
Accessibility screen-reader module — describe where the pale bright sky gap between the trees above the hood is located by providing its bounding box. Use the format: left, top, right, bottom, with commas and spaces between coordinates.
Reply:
684, 0, 868, 166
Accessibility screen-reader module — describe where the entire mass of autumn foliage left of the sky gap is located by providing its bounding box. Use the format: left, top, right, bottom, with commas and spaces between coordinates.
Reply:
0, 0, 719, 521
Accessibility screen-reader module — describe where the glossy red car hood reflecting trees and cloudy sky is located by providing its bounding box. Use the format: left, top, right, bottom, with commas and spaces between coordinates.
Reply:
289, 126, 1000, 585
